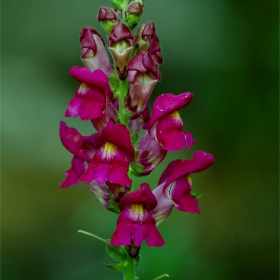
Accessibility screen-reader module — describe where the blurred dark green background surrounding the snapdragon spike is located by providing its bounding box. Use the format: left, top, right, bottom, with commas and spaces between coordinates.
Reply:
1, 0, 279, 280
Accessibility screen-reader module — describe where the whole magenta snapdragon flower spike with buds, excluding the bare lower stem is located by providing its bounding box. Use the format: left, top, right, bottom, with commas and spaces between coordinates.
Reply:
60, 0, 214, 253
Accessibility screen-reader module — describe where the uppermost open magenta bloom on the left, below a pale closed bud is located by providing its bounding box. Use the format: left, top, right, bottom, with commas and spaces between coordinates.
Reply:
65, 66, 113, 120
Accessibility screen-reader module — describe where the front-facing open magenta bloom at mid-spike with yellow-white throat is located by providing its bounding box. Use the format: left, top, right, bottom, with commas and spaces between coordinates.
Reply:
80, 121, 135, 186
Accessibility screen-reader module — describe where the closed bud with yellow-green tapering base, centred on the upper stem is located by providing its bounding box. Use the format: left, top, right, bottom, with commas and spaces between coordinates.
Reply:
108, 23, 133, 79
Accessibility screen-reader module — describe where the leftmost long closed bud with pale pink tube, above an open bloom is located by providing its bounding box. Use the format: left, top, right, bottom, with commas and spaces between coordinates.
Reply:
80, 26, 113, 75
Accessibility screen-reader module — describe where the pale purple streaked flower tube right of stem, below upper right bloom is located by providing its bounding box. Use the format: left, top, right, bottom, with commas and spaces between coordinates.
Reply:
137, 132, 167, 175
